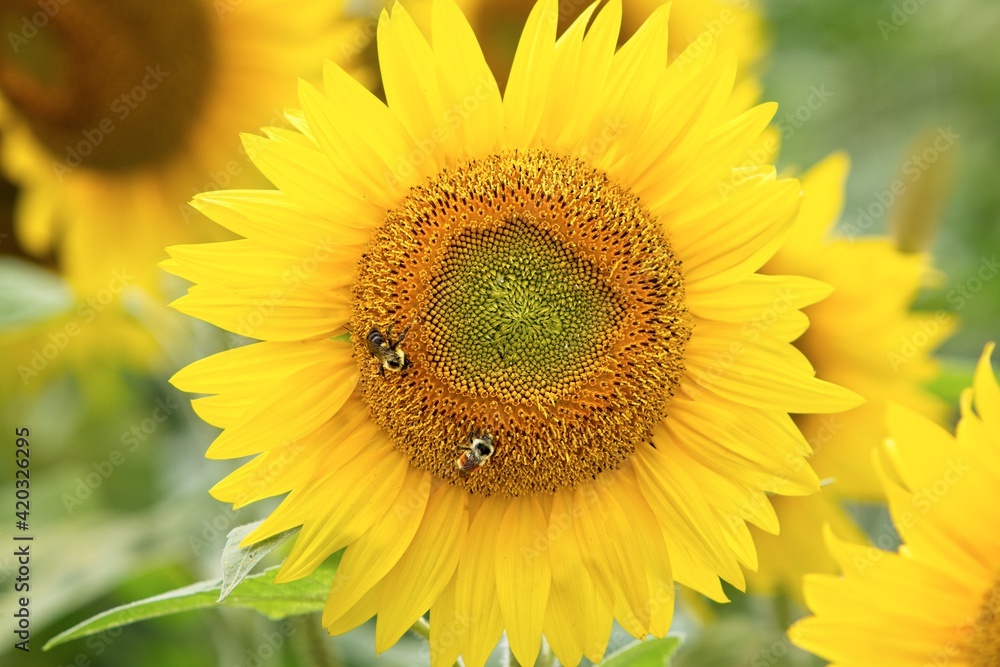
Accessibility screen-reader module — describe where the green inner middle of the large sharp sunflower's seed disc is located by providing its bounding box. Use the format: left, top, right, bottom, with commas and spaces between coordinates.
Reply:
424, 215, 624, 402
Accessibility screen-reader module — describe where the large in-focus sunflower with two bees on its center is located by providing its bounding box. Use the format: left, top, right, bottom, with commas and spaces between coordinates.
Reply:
165, 0, 859, 665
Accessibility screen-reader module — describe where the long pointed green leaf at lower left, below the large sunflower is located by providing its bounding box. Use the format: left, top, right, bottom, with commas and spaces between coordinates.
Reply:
44, 554, 340, 649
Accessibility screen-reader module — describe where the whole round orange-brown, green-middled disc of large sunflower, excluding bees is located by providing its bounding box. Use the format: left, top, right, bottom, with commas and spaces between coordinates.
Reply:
352, 151, 690, 496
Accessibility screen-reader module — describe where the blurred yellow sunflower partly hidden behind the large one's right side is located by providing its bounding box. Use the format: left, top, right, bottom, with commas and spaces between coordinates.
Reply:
750, 154, 953, 597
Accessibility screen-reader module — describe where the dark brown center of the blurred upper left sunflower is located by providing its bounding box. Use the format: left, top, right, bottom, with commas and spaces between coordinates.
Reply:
0, 0, 215, 170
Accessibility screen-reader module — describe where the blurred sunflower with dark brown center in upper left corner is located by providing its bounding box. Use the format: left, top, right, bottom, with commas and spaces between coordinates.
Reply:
0, 0, 348, 292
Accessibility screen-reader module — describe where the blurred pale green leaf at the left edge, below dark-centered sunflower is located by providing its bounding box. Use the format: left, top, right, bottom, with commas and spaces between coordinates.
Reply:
0, 257, 73, 329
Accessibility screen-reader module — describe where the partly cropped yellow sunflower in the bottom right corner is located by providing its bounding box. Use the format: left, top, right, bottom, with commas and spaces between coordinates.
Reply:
789, 344, 1000, 667
